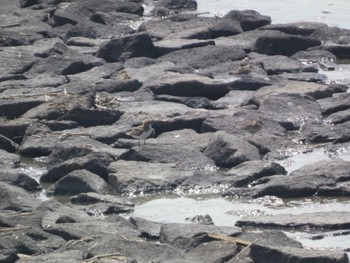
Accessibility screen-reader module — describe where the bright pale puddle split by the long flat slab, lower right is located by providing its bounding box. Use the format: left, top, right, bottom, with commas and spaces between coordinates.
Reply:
131, 196, 350, 255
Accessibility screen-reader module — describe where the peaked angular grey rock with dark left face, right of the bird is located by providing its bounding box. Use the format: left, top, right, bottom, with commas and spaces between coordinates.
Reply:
203, 131, 260, 167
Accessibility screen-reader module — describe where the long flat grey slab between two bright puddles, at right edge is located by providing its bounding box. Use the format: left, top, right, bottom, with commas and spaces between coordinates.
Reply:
236, 211, 350, 230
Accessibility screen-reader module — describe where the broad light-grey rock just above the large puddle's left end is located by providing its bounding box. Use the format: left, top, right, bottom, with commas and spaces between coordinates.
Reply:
108, 160, 200, 196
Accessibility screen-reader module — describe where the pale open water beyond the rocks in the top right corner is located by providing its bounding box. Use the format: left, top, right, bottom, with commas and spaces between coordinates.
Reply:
197, 0, 350, 28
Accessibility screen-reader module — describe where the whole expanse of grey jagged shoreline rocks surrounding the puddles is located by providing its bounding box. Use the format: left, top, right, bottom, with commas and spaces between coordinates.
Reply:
0, 0, 350, 263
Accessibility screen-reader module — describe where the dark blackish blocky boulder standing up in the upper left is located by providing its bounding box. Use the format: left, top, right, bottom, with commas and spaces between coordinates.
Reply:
96, 33, 155, 62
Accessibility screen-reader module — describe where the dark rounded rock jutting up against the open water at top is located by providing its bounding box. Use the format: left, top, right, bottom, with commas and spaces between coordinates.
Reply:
224, 10, 271, 31
